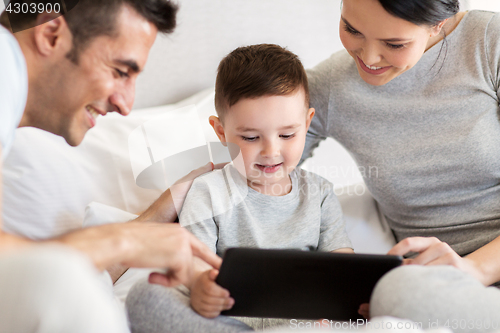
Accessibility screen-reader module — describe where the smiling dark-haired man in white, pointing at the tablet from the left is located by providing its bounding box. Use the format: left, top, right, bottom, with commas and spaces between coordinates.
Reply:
0, 0, 221, 332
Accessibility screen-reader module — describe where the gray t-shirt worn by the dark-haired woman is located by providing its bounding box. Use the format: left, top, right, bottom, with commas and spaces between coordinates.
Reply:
303, 11, 500, 255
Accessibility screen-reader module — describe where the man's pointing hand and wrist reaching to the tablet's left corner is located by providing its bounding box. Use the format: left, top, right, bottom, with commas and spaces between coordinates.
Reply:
53, 222, 222, 287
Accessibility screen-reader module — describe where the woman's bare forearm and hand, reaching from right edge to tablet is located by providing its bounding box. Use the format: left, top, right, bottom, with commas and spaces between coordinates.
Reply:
388, 236, 500, 286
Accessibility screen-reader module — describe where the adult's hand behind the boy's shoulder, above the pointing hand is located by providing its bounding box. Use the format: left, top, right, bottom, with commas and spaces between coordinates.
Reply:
135, 162, 226, 222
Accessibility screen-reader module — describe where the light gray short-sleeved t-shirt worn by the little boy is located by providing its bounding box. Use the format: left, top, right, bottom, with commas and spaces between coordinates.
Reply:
179, 164, 352, 256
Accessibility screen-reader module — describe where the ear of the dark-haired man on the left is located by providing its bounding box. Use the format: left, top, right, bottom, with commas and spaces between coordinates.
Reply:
33, 13, 73, 56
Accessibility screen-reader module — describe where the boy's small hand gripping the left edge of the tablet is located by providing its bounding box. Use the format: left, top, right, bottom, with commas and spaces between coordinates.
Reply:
191, 269, 234, 318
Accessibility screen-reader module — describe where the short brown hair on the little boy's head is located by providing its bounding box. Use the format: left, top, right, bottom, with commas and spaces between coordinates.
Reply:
215, 44, 309, 121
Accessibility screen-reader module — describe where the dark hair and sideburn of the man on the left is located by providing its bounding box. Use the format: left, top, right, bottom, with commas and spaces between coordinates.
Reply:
0, 0, 178, 62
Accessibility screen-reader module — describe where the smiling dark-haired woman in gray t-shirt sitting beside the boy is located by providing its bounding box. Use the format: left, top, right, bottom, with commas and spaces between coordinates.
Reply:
303, 0, 500, 330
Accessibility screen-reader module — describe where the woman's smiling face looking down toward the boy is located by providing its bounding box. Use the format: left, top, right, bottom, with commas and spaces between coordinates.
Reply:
340, 0, 444, 86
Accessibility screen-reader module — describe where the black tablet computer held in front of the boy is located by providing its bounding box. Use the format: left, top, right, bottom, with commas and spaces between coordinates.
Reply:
216, 248, 402, 320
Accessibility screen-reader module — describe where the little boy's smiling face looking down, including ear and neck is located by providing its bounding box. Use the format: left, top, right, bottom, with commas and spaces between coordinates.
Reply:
210, 88, 314, 195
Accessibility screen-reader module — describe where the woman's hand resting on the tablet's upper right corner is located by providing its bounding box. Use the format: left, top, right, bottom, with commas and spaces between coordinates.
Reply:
387, 237, 489, 284
